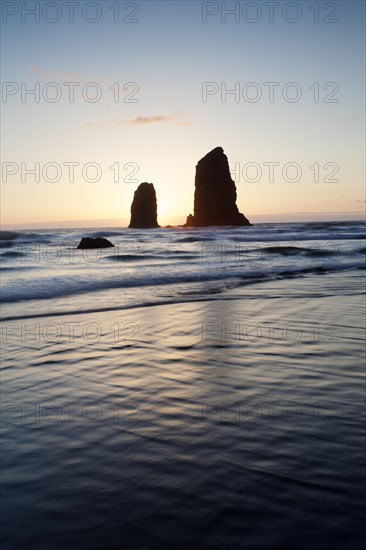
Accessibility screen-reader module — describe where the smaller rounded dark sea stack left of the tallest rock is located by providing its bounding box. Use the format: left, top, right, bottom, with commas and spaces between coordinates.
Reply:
128, 181, 159, 229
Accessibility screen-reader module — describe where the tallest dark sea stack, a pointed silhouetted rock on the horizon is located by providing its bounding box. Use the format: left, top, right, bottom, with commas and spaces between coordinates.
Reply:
186, 147, 251, 227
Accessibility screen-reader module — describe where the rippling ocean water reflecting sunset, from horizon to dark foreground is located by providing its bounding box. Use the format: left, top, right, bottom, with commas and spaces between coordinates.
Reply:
0, 222, 366, 550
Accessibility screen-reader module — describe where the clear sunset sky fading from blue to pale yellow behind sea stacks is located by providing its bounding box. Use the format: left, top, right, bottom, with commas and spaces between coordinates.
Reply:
1, 0, 365, 228
